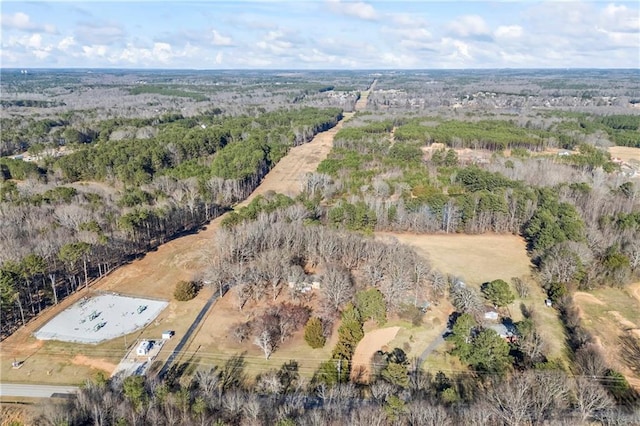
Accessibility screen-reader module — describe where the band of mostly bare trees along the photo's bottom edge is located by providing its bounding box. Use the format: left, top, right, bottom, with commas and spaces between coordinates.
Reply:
29, 350, 640, 426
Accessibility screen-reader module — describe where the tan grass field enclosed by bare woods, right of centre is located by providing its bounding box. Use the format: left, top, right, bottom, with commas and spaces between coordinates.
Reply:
376, 232, 531, 285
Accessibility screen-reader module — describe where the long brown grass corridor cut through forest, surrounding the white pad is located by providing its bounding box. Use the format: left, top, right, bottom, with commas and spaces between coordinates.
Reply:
0, 104, 366, 384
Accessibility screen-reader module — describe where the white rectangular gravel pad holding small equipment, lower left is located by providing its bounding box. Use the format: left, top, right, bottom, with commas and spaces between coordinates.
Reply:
34, 294, 168, 343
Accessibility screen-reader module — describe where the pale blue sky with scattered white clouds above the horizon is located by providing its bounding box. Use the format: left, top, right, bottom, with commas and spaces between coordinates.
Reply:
0, 0, 640, 69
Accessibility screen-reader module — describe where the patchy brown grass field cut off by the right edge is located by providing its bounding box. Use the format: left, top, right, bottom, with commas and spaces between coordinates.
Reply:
573, 282, 640, 389
